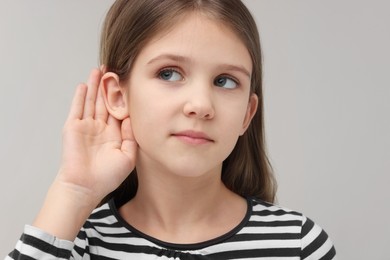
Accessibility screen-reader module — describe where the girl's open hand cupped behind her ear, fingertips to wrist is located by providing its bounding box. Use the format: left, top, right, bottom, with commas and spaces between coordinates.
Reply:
57, 69, 137, 203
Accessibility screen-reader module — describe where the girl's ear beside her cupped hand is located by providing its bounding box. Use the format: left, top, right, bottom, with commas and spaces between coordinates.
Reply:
101, 72, 129, 120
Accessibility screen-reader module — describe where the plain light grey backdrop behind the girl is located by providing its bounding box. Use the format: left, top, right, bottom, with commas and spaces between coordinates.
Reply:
0, 0, 390, 259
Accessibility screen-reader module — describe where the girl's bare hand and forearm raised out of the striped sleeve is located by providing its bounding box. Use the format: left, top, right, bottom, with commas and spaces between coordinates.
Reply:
6, 69, 137, 258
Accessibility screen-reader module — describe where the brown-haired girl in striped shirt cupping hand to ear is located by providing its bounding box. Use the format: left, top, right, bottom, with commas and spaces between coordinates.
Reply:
6, 0, 335, 259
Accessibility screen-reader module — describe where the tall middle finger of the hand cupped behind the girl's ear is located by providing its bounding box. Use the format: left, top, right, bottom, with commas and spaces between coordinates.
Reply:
84, 69, 101, 118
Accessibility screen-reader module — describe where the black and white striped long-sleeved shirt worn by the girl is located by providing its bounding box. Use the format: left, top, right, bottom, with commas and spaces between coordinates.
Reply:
6, 198, 336, 260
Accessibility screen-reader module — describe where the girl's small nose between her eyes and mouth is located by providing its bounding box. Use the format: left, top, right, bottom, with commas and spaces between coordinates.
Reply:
183, 84, 215, 119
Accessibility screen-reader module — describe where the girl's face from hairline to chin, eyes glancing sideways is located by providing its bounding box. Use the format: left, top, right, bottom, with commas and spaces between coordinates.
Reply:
124, 13, 257, 179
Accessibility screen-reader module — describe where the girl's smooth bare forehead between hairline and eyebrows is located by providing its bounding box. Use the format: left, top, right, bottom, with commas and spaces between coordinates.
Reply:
140, 12, 252, 71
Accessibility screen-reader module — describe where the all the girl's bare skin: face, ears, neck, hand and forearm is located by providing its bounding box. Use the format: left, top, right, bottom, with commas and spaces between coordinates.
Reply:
34, 13, 257, 243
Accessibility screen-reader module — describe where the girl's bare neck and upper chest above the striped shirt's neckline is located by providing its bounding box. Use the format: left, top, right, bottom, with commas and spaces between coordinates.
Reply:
120, 162, 246, 243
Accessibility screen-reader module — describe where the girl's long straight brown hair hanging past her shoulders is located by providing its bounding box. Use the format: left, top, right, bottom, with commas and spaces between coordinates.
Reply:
100, 0, 275, 204
